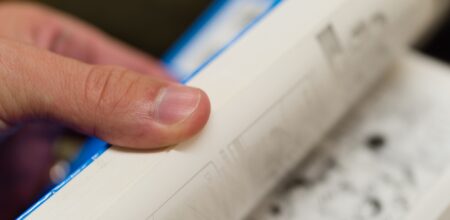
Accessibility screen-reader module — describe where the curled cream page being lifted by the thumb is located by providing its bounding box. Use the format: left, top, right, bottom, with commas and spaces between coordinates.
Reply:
22, 0, 450, 220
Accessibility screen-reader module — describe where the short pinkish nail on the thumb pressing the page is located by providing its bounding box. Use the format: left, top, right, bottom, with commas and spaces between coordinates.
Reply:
154, 86, 201, 125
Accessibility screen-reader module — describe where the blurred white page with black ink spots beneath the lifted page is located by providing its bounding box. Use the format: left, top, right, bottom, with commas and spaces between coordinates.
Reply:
249, 52, 450, 220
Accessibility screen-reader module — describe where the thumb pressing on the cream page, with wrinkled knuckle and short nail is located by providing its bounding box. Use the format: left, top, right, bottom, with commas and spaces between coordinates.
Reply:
0, 40, 210, 148
